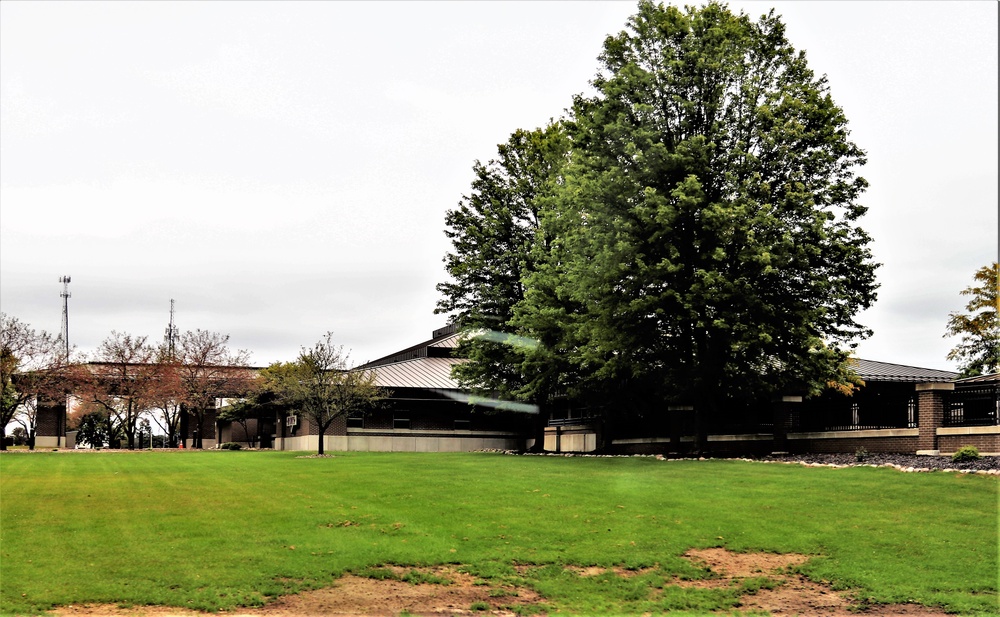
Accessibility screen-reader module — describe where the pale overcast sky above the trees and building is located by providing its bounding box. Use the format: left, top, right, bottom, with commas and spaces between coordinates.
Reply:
0, 1, 998, 368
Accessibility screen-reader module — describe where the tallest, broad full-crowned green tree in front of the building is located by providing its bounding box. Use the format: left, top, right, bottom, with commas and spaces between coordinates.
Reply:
516, 2, 877, 448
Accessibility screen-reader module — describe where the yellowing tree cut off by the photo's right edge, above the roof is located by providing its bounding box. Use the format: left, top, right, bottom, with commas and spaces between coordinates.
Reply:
945, 262, 1000, 377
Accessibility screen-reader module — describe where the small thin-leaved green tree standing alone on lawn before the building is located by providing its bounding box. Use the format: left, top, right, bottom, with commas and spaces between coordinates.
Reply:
265, 332, 388, 454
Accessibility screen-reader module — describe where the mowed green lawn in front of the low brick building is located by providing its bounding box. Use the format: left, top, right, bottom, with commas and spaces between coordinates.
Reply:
0, 451, 1000, 615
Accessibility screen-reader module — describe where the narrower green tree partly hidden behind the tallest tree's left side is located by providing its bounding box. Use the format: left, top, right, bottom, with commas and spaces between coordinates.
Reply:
435, 123, 569, 446
